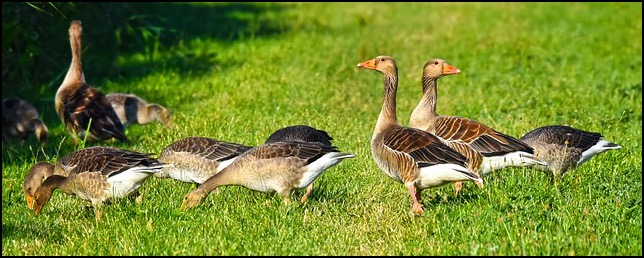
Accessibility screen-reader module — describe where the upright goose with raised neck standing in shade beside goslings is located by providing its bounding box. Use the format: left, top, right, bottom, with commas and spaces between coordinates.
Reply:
55, 20, 127, 143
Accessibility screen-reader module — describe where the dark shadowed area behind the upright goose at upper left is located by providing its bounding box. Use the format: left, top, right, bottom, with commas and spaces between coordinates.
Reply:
2, 3, 289, 163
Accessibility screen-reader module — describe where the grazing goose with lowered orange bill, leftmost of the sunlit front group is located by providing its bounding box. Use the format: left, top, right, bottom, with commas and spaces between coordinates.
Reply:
33, 146, 165, 218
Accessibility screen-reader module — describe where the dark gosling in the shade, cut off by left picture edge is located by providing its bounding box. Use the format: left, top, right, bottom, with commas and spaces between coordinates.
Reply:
2, 98, 48, 147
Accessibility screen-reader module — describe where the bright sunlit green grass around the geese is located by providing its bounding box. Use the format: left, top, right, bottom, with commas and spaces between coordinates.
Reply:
2, 3, 642, 256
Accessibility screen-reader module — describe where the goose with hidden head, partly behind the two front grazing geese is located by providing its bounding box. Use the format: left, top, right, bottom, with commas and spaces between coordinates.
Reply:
154, 137, 252, 184
